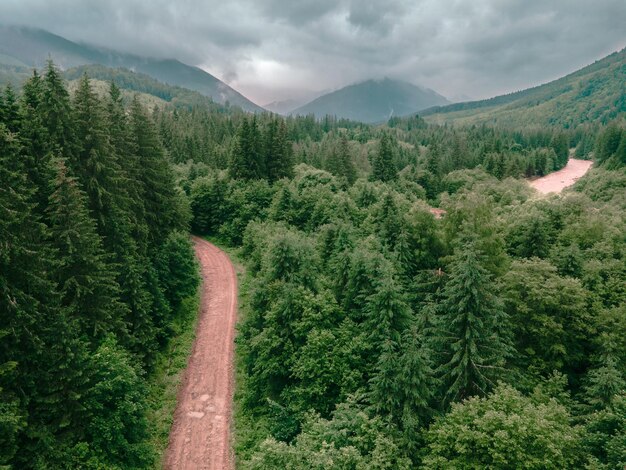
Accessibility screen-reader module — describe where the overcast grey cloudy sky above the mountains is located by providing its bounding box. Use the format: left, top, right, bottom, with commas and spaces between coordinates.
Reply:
0, 0, 626, 104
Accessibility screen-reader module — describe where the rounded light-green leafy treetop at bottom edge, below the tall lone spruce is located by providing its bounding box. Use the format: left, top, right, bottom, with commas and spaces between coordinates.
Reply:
423, 385, 583, 469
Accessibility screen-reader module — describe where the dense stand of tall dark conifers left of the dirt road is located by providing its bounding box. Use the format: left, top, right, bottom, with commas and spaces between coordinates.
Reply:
0, 63, 198, 469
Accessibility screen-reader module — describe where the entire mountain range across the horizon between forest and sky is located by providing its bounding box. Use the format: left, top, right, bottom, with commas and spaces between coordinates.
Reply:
0, 25, 626, 127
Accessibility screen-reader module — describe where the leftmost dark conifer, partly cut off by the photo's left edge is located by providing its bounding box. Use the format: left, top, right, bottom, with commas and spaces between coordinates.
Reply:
0, 124, 88, 468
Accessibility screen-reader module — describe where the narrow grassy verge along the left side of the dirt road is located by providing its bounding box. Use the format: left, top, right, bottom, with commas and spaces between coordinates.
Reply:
147, 284, 202, 469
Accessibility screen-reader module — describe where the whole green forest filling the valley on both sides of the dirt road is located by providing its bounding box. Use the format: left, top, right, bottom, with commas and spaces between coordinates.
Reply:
0, 63, 626, 469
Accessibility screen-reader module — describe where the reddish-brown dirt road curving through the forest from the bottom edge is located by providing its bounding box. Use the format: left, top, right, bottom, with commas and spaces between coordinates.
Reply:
165, 237, 237, 470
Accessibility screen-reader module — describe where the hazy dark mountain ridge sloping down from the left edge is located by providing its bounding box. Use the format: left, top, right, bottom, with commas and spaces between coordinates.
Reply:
0, 26, 263, 111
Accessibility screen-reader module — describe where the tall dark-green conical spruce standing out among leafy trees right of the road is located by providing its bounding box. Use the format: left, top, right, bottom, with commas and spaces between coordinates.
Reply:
434, 240, 512, 402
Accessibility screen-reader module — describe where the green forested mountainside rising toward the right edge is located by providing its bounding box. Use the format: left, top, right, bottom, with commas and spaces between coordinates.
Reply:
420, 49, 626, 127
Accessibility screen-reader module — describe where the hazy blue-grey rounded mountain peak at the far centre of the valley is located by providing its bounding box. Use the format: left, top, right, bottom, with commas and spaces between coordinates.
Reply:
291, 78, 449, 123
